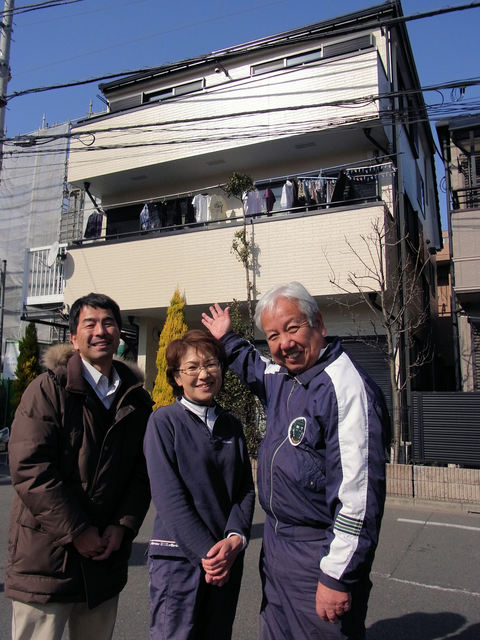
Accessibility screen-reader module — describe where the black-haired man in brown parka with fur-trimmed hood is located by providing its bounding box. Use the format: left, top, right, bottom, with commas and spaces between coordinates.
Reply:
5, 293, 152, 640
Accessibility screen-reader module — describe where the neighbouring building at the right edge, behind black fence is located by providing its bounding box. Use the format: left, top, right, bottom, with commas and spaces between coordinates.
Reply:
437, 115, 480, 391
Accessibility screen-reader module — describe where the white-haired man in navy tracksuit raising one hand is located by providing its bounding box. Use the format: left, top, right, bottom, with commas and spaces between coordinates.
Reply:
202, 282, 389, 640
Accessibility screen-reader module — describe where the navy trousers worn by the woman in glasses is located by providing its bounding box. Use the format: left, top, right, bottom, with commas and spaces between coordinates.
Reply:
148, 552, 244, 640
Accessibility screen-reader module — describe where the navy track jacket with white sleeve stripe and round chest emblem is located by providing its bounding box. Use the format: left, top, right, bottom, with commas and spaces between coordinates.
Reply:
222, 332, 390, 591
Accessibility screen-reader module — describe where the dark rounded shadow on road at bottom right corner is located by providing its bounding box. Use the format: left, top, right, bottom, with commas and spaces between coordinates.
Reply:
367, 612, 480, 640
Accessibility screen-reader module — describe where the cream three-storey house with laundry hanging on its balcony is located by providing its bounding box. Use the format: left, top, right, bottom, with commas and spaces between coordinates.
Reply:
22, 1, 442, 436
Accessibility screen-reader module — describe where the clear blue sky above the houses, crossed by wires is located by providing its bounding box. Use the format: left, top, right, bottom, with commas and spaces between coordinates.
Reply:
6, 0, 480, 228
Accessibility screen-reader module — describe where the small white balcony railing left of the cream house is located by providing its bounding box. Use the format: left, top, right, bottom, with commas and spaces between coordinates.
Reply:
23, 243, 67, 307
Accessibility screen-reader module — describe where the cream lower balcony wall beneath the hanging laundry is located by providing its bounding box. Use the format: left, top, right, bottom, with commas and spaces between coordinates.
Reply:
65, 200, 386, 322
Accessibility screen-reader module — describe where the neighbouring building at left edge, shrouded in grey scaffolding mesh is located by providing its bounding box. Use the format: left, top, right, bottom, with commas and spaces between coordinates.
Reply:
0, 123, 97, 378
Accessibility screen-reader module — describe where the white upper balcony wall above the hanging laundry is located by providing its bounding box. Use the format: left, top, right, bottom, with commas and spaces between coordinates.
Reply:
68, 47, 388, 207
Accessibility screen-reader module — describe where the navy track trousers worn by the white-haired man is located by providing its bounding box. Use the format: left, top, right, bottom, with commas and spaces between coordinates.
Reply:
260, 517, 372, 640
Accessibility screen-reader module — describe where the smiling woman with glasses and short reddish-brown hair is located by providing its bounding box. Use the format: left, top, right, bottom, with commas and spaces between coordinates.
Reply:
144, 330, 255, 640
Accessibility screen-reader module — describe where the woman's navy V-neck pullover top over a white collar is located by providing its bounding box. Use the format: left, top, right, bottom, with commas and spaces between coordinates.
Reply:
144, 400, 255, 565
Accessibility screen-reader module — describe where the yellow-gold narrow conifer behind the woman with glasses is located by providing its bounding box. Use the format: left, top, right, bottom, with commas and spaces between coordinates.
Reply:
152, 287, 188, 409
